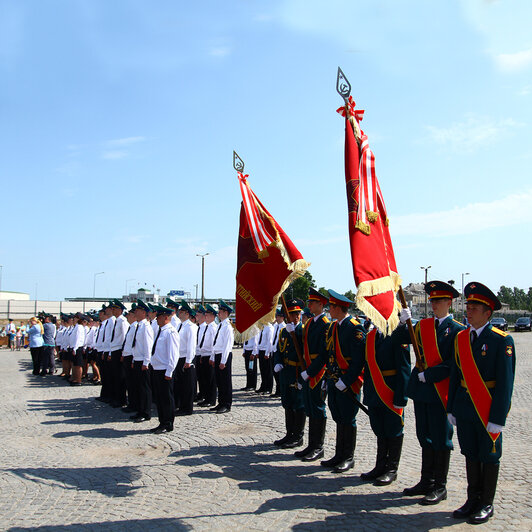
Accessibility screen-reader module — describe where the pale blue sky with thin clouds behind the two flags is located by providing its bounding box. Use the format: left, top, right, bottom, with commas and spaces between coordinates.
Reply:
0, 0, 532, 299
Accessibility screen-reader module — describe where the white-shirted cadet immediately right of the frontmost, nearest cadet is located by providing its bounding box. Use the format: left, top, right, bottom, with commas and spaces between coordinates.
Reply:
174, 300, 197, 416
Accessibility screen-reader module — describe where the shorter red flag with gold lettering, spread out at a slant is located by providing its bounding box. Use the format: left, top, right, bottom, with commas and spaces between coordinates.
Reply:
235, 159, 309, 341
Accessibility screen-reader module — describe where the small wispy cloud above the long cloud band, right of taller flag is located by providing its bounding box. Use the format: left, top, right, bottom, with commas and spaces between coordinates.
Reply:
426, 114, 523, 151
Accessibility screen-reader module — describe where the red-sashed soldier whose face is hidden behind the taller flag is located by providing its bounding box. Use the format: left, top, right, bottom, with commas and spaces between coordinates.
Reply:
360, 326, 410, 486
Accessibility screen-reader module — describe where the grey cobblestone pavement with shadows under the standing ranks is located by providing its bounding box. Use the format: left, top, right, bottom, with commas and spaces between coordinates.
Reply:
0, 333, 532, 532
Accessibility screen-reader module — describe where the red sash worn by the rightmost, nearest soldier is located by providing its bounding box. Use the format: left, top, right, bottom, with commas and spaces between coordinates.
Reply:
456, 329, 500, 452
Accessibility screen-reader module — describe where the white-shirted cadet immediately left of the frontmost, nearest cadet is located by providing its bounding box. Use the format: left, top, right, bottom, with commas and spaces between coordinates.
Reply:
129, 299, 154, 423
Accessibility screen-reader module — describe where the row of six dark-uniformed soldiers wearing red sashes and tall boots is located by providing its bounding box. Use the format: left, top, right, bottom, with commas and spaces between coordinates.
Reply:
274, 281, 515, 524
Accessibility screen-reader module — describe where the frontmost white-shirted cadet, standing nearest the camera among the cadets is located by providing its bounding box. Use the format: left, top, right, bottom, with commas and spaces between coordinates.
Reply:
150, 305, 180, 434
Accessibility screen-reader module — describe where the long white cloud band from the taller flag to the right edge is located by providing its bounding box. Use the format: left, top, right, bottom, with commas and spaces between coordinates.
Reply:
390, 189, 532, 238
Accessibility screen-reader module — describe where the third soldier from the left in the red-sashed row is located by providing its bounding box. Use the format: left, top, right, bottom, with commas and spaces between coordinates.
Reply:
316, 290, 366, 473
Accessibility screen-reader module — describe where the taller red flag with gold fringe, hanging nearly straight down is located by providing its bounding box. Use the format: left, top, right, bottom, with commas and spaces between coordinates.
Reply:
337, 90, 401, 335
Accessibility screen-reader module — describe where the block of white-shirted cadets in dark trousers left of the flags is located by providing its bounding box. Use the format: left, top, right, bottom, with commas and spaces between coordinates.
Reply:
56, 298, 234, 434
